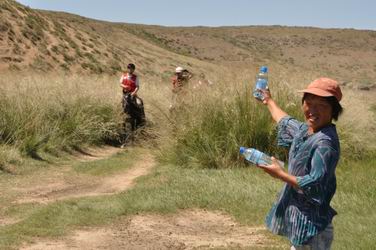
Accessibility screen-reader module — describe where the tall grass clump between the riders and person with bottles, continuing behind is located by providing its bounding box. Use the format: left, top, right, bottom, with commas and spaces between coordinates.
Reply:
162, 69, 372, 168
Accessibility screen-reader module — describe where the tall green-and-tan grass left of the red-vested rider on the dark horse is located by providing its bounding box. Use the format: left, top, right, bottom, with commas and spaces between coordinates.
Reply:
0, 75, 121, 161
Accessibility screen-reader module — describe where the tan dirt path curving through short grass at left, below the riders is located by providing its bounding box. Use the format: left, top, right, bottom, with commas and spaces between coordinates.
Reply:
0, 146, 155, 226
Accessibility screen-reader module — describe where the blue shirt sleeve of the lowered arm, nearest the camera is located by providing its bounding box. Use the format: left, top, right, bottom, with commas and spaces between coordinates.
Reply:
296, 142, 339, 204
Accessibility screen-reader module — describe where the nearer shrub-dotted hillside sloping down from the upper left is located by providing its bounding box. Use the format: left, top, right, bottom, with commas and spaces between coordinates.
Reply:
0, 0, 217, 76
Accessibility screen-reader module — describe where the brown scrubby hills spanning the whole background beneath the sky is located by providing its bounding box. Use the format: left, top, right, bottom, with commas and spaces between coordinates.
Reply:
0, 0, 376, 82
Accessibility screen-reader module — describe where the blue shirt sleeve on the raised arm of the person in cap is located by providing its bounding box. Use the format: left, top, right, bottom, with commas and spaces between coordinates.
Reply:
277, 116, 303, 147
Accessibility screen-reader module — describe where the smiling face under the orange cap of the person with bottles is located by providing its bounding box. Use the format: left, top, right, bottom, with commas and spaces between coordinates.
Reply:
303, 94, 332, 133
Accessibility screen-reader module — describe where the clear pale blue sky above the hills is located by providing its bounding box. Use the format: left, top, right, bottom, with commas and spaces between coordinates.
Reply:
17, 0, 376, 30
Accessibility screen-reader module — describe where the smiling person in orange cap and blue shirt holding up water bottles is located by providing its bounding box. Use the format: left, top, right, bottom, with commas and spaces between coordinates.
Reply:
260, 78, 342, 249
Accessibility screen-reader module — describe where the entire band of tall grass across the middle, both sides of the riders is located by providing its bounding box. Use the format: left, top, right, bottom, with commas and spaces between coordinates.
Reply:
0, 67, 374, 168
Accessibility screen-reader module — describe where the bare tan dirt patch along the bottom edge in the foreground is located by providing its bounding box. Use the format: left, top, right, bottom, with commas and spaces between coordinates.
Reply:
21, 210, 278, 250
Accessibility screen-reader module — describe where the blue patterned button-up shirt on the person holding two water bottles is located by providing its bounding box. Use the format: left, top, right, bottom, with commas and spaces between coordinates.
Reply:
266, 116, 340, 246
